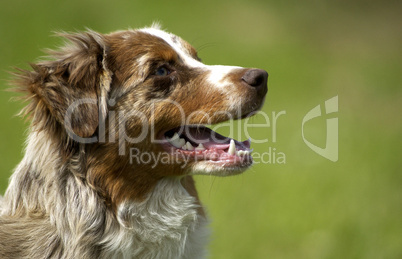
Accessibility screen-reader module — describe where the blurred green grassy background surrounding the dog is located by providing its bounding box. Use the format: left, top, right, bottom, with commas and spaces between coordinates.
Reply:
0, 0, 402, 259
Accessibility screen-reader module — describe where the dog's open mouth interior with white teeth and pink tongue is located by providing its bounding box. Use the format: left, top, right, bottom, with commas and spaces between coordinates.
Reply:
159, 125, 252, 167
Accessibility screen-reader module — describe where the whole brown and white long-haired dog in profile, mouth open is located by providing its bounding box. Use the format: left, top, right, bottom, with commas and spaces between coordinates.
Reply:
0, 23, 268, 259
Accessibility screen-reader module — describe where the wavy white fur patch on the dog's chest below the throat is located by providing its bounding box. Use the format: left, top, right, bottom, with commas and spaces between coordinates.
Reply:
103, 179, 208, 258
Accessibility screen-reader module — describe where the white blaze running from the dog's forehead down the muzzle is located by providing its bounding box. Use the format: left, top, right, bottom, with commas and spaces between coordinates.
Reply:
140, 27, 242, 87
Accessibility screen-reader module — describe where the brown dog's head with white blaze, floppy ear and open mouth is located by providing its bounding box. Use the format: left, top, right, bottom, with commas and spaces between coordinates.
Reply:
16, 24, 268, 203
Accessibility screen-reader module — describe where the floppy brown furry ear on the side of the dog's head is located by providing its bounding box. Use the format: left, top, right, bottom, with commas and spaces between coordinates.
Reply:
20, 31, 112, 138
